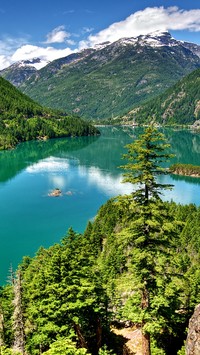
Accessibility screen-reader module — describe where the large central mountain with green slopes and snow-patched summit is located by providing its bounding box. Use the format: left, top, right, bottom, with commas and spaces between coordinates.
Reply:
13, 32, 200, 119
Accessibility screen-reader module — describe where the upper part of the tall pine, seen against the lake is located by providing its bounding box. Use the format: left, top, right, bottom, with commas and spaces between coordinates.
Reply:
122, 126, 172, 205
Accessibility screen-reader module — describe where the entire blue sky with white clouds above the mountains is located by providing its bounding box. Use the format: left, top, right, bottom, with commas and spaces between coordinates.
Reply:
0, 0, 200, 69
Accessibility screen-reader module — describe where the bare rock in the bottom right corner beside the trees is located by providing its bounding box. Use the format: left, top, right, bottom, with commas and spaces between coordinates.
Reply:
185, 304, 200, 355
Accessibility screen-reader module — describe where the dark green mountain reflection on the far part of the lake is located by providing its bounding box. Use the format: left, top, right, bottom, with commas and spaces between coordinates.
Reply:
0, 127, 200, 181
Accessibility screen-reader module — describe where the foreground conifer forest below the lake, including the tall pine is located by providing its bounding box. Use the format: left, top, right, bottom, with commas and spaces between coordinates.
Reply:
0, 127, 200, 355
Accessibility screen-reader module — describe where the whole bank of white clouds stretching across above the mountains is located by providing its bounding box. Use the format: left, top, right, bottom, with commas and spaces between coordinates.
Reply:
0, 6, 200, 69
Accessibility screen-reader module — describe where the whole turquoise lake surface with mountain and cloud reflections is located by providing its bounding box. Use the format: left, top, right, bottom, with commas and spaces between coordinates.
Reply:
0, 127, 200, 284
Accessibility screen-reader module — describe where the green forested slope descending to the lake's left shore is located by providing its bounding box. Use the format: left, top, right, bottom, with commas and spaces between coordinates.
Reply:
0, 78, 99, 149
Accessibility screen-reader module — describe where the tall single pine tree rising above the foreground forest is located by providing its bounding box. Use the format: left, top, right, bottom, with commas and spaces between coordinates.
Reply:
122, 126, 174, 355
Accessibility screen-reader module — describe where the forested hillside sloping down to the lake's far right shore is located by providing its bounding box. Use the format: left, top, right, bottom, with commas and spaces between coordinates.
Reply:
123, 69, 200, 124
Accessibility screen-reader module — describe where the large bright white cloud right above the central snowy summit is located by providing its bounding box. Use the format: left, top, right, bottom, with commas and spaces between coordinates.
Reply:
80, 6, 200, 48
